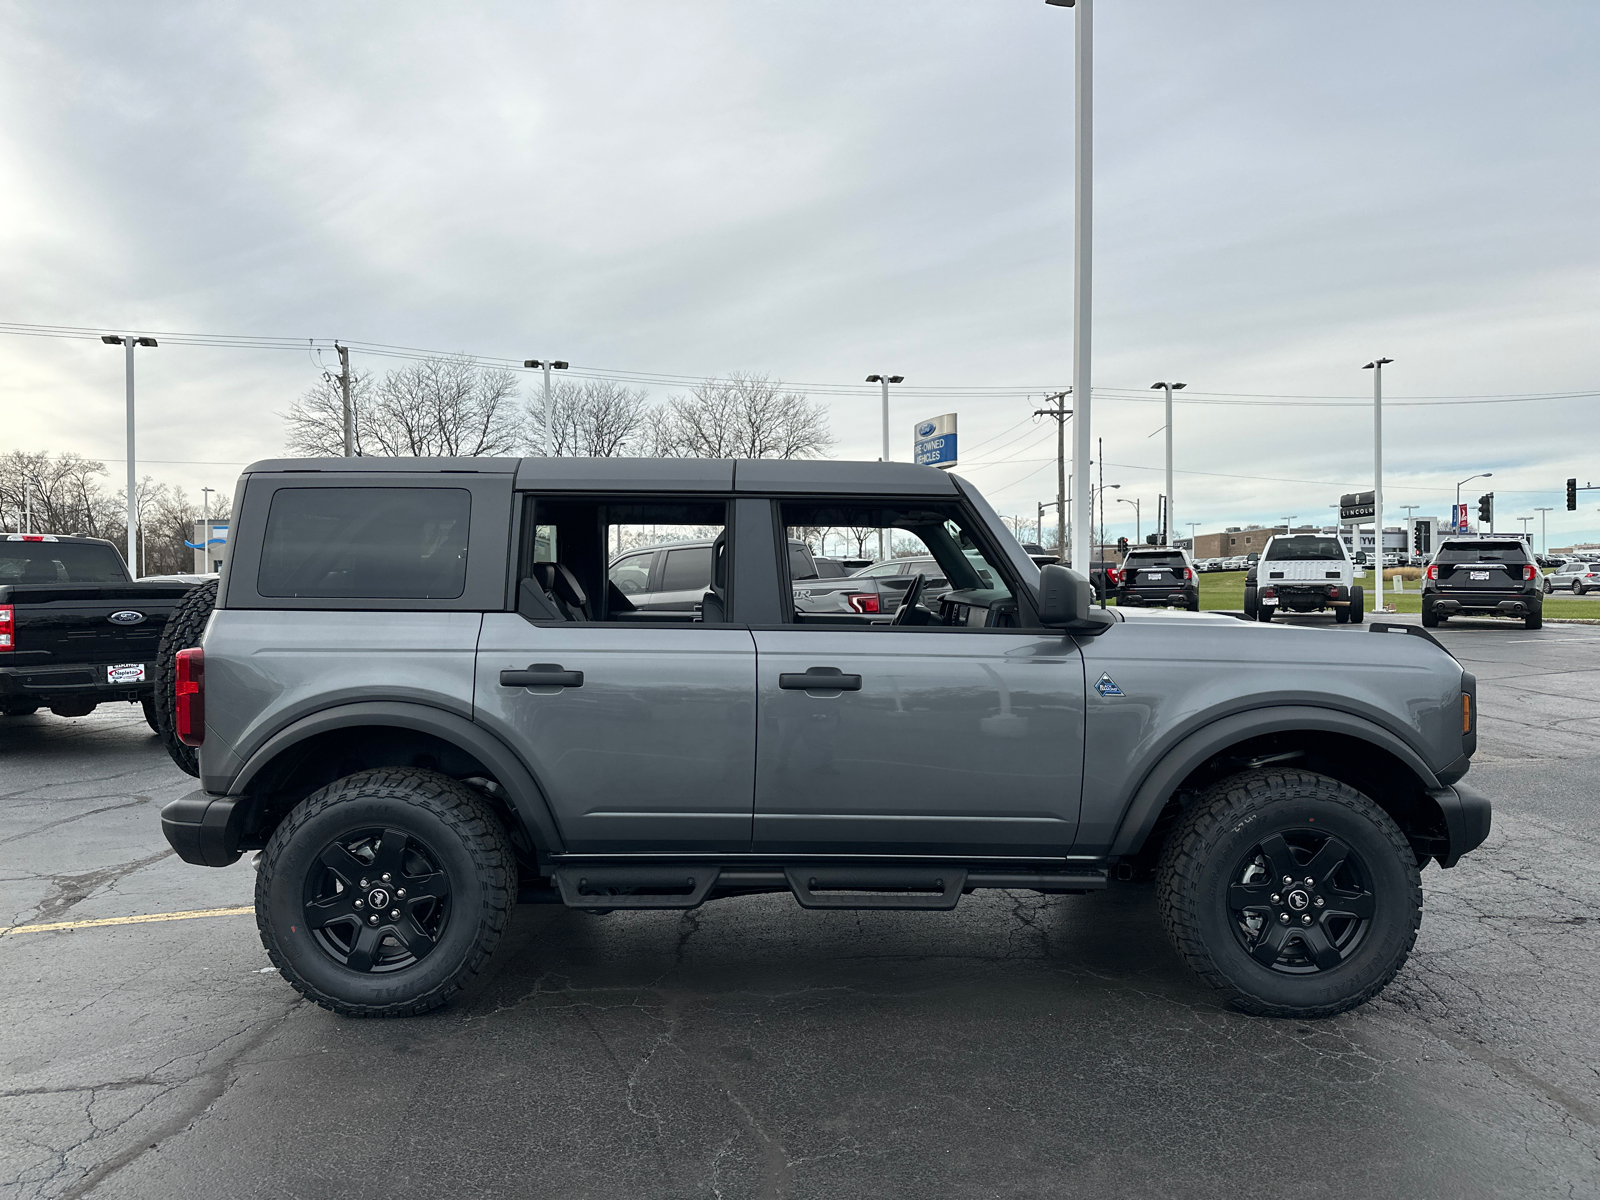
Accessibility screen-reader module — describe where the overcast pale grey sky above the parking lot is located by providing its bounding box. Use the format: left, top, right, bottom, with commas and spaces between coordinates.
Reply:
0, 0, 1600, 544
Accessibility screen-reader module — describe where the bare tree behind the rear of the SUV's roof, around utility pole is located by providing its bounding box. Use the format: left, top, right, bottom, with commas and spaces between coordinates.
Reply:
285, 355, 522, 458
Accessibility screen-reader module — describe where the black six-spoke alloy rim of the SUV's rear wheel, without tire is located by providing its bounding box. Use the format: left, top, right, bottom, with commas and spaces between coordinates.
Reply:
301, 829, 450, 973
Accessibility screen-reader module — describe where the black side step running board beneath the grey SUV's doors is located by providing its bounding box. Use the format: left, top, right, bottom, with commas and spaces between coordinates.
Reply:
554, 862, 1106, 910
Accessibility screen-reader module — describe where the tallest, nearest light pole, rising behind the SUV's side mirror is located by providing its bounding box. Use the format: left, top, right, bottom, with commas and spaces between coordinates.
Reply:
1045, 0, 1094, 578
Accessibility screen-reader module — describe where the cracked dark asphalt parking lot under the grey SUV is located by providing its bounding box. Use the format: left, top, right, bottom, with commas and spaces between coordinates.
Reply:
0, 618, 1600, 1200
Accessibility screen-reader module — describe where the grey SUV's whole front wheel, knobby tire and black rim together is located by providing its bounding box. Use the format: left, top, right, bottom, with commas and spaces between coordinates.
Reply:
1157, 771, 1422, 1018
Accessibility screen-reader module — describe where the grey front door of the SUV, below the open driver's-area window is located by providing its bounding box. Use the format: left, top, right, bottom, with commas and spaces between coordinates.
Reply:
754, 501, 1085, 859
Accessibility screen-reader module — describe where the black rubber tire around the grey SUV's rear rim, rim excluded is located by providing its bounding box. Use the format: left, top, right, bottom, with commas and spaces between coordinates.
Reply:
256, 768, 517, 1016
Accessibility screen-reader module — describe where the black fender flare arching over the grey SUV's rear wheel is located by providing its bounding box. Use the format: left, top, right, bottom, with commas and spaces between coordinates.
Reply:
227, 701, 565, 854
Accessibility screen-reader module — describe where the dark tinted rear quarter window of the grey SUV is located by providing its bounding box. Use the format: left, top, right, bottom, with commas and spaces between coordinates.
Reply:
256, 488, 472, 600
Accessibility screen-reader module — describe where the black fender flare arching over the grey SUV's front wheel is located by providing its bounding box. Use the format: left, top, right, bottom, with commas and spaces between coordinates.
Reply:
1110, 704, 1440, 856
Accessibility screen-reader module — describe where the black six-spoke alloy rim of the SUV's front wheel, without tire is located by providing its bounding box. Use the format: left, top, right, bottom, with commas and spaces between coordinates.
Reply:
1227, 826, 1376, 974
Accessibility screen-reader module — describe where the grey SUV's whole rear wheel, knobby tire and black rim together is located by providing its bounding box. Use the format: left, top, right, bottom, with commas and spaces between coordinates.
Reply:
256, 768, 517, 1016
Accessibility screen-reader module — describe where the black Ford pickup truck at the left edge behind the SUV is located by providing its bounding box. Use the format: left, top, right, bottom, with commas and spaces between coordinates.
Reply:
0, 533, 192, 730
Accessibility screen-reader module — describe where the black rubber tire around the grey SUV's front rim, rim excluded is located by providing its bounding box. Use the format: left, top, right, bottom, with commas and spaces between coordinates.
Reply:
1157, 770, 1422, 1018
